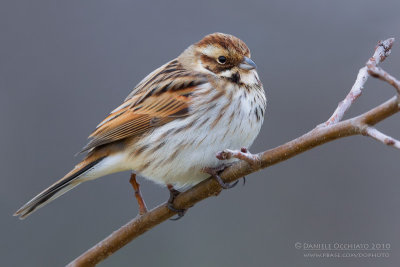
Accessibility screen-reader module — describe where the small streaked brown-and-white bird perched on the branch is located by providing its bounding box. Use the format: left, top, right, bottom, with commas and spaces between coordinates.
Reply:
14, 33, 267, 219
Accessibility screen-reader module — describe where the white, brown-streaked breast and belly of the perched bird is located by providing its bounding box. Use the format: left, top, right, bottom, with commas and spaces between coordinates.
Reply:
128, 74, 265, 188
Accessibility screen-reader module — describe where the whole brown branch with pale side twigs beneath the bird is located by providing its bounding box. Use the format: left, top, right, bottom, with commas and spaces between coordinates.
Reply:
68, 38, 400, 266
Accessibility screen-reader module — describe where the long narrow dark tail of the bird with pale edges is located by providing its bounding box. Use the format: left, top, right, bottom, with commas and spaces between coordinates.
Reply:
14, 157, 105, 220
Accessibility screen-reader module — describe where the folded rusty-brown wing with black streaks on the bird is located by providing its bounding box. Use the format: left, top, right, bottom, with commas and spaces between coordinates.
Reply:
82, 60, 208, 152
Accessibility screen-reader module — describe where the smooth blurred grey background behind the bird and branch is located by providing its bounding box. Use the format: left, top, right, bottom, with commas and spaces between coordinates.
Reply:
0, 0, 400, 266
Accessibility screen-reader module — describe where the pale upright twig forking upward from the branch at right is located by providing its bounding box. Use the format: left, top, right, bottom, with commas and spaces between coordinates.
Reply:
325, 38, 394, 125
